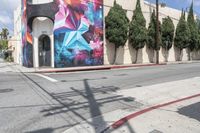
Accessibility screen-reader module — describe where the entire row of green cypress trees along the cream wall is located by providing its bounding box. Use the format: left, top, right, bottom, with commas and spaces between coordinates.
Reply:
105, 0, 200, 63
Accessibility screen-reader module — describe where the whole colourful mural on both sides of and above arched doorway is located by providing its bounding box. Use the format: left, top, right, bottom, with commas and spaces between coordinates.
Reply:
22, 0, 103, 68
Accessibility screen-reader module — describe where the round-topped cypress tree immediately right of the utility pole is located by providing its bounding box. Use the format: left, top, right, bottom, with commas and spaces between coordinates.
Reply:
162, 16, 175, 61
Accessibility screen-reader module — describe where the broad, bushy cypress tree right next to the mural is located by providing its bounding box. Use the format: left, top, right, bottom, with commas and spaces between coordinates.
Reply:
105, 0, 129, 64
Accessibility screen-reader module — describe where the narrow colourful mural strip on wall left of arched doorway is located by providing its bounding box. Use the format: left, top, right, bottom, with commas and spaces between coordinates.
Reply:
22, 0, 33, 67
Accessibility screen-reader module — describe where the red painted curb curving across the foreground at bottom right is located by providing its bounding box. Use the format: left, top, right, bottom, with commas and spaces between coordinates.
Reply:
110, 94, 200, 129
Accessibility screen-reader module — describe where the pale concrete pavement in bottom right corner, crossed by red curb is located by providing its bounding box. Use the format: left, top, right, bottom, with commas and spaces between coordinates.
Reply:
64, 77, 200, 133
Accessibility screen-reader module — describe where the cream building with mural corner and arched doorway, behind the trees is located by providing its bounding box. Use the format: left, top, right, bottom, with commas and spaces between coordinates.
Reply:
14, 0, 200, 68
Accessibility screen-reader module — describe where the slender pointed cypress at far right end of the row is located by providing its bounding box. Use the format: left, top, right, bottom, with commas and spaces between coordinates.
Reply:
187, 2, 198, 60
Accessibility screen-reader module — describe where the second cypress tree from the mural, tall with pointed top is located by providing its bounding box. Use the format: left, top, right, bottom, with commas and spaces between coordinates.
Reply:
129, 0, 147, 63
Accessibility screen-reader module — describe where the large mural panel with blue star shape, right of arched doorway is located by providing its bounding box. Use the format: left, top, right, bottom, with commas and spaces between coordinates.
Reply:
54, 0, 103, 68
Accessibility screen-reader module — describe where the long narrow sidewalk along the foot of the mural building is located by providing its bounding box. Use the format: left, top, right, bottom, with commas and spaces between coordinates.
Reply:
1, 59, 200, 73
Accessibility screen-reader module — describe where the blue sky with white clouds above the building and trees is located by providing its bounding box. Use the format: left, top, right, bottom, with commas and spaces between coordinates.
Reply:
0, 0, 200, 34
